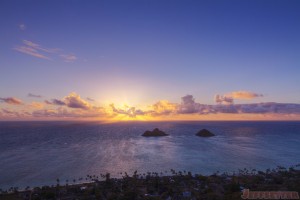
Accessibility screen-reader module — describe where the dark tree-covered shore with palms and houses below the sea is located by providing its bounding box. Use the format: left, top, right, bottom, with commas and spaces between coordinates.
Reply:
0, 164, 300, 200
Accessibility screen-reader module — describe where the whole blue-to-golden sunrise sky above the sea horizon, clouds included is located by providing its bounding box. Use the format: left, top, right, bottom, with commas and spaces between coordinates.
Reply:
0, 0, 300, 121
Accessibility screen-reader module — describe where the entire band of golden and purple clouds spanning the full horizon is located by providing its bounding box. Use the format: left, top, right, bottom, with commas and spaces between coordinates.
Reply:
0, 92, 300, 119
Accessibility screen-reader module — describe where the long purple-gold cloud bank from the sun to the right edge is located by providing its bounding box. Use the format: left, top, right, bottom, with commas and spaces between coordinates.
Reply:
106, 95, 300, 118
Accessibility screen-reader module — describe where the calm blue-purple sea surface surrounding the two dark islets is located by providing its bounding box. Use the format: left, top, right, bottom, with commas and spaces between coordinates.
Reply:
0, 122, 300, 189
